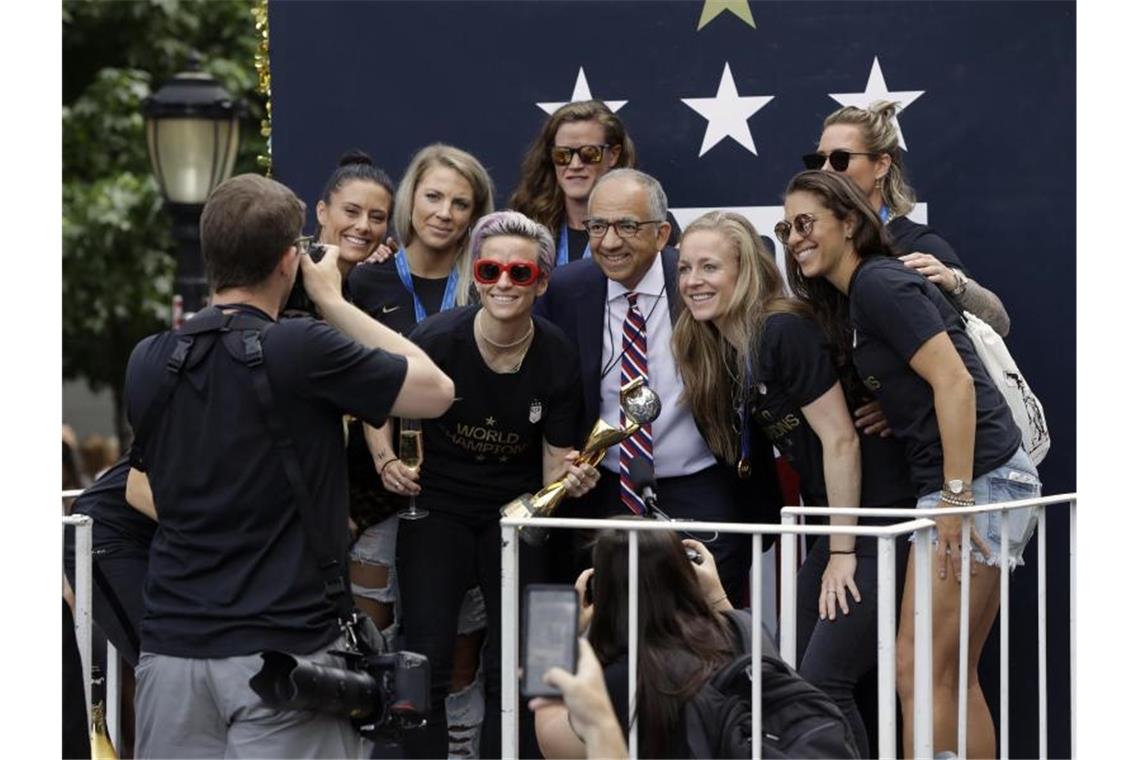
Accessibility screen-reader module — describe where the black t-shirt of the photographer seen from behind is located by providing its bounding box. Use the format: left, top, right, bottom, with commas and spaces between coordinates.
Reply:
127, 307, 407, 657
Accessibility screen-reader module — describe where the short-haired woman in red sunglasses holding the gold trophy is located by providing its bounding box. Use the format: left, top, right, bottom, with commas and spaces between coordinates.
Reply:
385, 211, 599, 758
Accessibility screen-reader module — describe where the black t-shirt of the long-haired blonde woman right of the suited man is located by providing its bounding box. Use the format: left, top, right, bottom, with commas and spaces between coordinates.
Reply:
749, 313, 914, 507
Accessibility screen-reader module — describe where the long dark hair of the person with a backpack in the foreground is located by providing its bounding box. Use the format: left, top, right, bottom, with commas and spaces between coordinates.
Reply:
589, 517, 738, 758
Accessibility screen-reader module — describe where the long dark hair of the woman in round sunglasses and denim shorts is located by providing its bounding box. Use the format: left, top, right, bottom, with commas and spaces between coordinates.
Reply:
784, 170, 898, 402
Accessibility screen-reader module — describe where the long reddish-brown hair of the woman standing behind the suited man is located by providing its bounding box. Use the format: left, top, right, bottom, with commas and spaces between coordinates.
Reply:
506, 100, 637, 235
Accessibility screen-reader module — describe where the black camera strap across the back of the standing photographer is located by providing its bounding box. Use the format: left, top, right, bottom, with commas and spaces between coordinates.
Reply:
136, 307, 355, 627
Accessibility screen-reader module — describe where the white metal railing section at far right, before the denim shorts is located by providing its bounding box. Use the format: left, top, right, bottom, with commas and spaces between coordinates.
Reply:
780, 493, 1076, 760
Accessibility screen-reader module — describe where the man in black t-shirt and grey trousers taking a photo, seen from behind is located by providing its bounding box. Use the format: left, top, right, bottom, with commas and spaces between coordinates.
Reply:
127, 174, 454, 758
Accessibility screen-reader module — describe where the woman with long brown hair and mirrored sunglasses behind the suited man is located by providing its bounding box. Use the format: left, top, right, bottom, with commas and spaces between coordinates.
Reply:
506, 100, 681, 267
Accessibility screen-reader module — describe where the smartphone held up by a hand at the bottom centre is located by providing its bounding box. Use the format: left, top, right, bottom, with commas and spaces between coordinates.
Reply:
520, 583, 578, 700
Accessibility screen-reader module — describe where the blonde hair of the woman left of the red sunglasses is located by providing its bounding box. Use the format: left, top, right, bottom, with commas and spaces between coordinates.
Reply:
392, 142, 495, 307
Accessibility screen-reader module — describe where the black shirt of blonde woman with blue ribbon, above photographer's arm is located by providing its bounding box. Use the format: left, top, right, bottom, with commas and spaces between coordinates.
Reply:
348, 254, 453, 335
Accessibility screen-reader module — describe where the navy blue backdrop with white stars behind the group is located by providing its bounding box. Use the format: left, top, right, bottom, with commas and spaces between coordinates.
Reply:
270, 0, 1076, 757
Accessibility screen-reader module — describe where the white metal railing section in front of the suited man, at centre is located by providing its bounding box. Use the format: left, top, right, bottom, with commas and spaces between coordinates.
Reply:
499, 517, 935, 760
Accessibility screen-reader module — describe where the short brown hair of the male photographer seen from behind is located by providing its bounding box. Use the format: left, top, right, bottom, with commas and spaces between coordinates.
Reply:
200, 174, 304, 292
